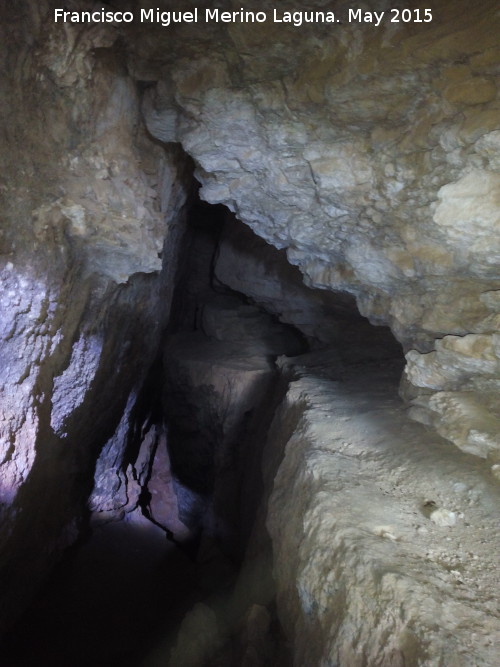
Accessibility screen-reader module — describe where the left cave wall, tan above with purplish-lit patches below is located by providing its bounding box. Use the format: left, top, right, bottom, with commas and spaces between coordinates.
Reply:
0, 1, 189, 624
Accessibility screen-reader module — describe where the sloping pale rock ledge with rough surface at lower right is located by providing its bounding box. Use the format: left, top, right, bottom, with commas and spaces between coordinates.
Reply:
264, 353, 500, 667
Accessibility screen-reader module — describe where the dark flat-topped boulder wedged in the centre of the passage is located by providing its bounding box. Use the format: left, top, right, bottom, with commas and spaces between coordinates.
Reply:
164, 295, 301, 556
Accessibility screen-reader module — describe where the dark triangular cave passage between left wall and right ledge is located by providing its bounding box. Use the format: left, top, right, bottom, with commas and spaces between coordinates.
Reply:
3, 194, 402, 667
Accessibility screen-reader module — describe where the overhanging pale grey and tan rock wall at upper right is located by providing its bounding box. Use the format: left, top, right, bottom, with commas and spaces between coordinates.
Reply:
138, 0, 500, 464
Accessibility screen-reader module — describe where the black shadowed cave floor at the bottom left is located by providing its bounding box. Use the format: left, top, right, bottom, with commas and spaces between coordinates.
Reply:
1, 516, 201, 667
